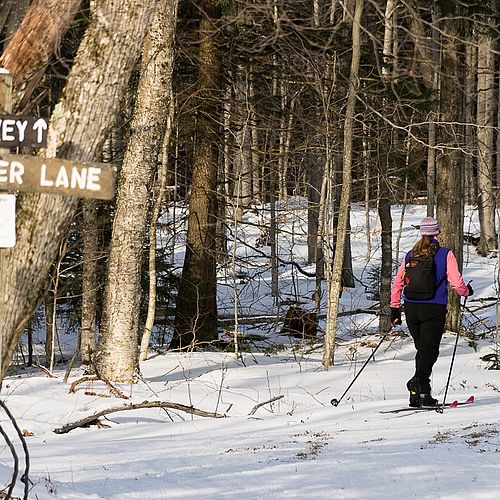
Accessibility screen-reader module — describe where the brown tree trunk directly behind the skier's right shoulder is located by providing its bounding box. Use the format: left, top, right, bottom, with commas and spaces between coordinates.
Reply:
436, 8, 464, 332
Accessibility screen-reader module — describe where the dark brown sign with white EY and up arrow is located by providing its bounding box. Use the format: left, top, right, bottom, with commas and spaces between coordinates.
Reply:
0, 115, 48, 148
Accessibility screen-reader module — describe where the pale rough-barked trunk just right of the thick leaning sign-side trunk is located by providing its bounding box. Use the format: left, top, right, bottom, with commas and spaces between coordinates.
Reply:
97, 0, 177, 382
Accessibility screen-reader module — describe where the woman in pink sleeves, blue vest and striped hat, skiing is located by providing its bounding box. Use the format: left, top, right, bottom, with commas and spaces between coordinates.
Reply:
391, 217, 473, 408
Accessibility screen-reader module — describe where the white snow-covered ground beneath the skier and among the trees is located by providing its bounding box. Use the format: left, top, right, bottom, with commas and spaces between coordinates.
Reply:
0, 206, 500, 500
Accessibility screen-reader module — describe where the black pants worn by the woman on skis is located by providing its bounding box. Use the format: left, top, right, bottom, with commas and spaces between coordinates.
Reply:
404, 302, 446, 394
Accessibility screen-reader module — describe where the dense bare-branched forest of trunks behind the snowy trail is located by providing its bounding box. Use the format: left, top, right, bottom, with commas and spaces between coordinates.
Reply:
0, 0, 500, 402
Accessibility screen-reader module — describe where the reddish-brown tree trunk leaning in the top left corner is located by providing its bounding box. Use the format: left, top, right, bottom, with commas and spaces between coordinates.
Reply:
0, 0, 82, 108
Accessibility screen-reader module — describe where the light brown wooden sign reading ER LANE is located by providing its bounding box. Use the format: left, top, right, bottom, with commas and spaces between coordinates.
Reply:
0, 154, 115, 200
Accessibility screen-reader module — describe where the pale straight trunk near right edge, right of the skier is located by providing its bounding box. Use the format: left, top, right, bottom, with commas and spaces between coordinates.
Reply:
477, 25, 497, 256
